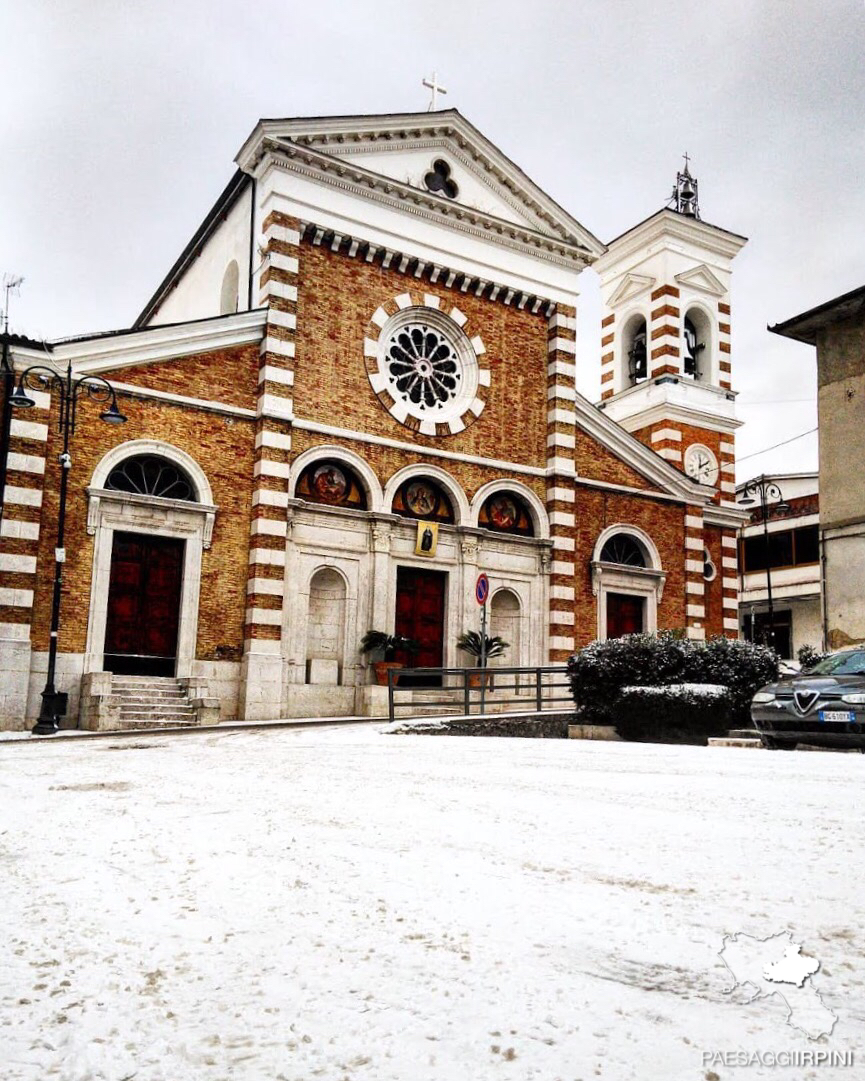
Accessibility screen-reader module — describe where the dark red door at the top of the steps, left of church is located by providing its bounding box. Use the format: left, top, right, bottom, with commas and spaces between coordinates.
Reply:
104, 533, 185, 676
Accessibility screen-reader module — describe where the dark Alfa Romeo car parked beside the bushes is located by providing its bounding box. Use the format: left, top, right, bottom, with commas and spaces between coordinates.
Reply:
750, 648, 865, 750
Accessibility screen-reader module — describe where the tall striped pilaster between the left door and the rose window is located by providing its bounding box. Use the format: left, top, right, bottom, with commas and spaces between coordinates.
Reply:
240, 213, 301, 720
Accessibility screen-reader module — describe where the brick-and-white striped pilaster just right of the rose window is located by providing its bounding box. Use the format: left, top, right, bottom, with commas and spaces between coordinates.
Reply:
547, 305, 576, 664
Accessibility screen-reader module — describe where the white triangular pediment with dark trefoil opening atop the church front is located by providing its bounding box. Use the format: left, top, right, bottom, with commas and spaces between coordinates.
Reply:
237, 109, 604, 256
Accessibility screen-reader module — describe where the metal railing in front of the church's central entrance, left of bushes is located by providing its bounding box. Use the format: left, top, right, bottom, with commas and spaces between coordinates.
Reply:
387, 665, 573, 721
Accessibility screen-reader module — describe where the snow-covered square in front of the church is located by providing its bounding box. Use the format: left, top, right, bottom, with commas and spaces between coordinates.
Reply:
0, 729, 865, 1081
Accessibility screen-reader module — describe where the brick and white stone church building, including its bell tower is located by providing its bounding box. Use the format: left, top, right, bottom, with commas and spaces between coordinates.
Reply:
0, 110, 744, 728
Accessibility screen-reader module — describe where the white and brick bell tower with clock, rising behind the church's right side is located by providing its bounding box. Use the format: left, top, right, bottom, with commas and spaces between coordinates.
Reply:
595, 162, 746, 505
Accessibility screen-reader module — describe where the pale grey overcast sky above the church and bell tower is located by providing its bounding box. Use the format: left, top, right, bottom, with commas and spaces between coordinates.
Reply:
0, 0, 865, 480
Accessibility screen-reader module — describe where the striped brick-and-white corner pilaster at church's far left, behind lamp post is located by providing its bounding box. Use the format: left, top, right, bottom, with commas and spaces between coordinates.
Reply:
0, 390, 53, 729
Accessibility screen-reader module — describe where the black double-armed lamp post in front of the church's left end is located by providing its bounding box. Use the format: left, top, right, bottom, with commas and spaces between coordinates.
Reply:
9, 361, 127, 736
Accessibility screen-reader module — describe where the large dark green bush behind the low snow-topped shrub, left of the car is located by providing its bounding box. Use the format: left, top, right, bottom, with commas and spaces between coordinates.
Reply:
568, 630, 779, 734
